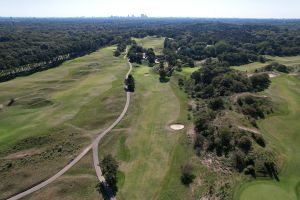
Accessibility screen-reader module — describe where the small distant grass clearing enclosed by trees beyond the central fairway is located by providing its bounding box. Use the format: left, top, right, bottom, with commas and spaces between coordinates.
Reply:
133, 36, 165, 55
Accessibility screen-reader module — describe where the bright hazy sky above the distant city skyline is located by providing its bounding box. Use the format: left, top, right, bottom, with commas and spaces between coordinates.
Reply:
0, 0, 300, 18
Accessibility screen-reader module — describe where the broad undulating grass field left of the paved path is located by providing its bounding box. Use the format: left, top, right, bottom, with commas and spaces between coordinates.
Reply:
0, 47, 128, 199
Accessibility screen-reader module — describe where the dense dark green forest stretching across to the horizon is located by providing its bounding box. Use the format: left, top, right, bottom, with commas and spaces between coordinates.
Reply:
0, 18, 300, 81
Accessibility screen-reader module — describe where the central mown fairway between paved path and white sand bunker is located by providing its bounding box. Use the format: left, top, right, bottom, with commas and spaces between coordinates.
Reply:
96, 62, 190, 199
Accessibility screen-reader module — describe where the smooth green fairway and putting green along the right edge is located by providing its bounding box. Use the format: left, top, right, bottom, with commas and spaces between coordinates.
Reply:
236, 75, 300, 200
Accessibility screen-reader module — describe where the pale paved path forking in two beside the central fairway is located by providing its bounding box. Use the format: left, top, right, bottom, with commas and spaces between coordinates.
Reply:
8, 57, 132, 200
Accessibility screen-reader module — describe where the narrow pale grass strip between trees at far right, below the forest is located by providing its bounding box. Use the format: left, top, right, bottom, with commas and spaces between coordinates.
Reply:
232, 56, 300, 72
